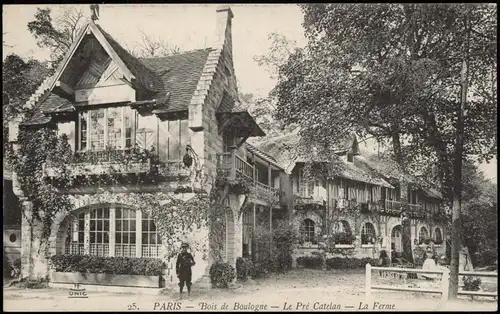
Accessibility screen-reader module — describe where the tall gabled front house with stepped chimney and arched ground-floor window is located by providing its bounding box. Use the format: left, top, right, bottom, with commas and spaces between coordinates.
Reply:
7, 6, 288, 284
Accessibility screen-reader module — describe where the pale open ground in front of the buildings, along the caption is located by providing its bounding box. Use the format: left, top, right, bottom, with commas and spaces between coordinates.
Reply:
4, 269, 497, 311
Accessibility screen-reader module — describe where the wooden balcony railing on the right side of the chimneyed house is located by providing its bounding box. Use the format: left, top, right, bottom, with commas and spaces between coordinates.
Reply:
217, 153, 282, 200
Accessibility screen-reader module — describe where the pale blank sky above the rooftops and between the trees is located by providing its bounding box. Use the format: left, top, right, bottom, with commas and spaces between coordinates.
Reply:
2, 4, 497, 183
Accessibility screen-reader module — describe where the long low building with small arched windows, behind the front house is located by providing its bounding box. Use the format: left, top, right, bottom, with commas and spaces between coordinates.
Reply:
284, 137, 447, 260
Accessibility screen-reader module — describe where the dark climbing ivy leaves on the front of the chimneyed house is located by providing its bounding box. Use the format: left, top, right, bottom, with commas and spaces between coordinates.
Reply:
6, 122, 231, 259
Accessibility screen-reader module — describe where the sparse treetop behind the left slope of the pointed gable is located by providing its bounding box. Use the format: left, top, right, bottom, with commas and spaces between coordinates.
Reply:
28, 7, 85, 68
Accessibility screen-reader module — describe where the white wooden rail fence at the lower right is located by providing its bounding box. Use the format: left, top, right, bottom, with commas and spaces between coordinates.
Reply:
365, 264, 498, 301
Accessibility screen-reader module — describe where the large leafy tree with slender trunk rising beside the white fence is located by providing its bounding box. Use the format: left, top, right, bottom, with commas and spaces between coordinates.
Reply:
274, 4, 496, 298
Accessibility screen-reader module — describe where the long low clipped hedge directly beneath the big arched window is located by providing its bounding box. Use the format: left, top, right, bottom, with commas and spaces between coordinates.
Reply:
50, 254, 165, 276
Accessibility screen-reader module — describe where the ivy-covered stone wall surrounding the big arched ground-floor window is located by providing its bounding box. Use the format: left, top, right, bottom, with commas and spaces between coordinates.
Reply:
7, 125, 230, 277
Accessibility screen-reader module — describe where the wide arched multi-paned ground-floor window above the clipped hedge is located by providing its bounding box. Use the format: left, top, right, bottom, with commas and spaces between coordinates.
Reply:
64, 206, 161, 257
